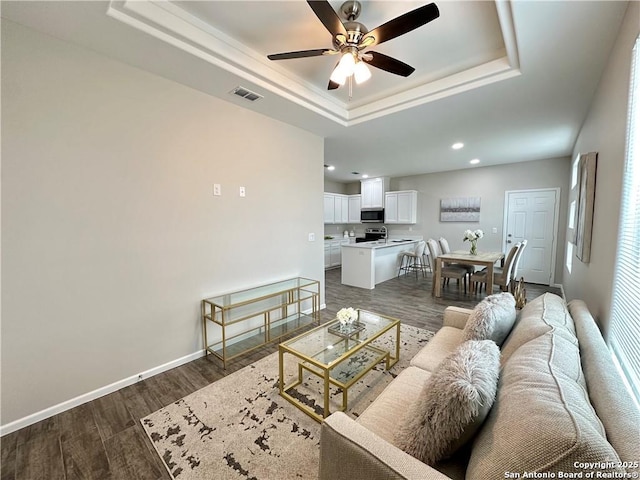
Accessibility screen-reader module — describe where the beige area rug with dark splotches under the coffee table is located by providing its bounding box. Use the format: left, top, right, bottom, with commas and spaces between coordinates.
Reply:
141, 325, 433, 480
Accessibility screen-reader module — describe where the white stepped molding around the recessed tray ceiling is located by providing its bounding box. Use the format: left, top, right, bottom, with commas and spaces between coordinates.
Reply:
107, 0, 521, 127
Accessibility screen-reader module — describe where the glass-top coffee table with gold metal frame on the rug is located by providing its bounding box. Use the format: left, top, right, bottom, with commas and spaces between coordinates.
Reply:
278, 310, 400, 422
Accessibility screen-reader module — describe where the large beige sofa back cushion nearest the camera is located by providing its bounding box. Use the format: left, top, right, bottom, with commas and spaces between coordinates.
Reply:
467, 327, 618, 479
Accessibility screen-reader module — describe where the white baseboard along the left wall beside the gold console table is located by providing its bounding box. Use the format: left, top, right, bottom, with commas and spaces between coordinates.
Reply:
0, 303, 326, 437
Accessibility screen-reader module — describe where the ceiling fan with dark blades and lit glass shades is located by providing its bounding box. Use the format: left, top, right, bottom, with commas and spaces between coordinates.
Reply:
267, 0, 440, 90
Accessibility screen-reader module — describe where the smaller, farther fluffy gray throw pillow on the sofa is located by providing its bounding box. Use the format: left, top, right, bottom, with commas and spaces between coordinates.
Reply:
462, 292, 516, 346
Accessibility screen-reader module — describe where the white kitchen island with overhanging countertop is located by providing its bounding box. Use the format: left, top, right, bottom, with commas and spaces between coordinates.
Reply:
342, 240, 419, 290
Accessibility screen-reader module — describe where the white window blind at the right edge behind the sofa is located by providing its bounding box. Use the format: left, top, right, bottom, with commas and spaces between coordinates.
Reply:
609, 36, 640, 401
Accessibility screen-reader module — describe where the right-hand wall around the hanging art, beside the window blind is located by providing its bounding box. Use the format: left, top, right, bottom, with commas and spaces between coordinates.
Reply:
564, 2, 640, 335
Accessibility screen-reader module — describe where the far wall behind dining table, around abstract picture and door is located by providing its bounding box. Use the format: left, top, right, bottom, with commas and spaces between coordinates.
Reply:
390, 157, 570, 283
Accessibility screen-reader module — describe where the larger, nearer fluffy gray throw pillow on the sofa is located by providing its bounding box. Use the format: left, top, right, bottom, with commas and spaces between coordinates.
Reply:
395, 340, 500, 465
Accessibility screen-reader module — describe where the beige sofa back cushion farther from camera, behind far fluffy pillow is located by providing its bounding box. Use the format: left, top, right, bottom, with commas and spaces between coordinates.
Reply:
501, 293, 575, 364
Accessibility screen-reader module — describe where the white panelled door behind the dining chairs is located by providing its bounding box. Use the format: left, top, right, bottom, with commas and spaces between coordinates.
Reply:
504, 188, 560, 285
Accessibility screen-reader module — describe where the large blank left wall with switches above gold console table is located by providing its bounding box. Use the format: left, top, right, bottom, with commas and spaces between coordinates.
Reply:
1, 21, 324, 425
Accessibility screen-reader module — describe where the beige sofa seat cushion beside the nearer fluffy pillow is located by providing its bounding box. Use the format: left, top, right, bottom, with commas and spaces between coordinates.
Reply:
358, 367, 431, 443
